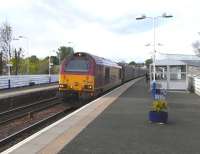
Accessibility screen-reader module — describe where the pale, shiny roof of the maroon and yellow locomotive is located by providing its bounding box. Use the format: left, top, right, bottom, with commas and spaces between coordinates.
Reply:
75, 52, 121, 68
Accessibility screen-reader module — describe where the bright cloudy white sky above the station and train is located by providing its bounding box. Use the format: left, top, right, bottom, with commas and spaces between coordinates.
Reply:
0, 0, 200, 62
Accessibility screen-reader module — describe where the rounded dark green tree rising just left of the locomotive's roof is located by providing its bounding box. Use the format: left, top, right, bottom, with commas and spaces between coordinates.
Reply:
57, 46, 74, 62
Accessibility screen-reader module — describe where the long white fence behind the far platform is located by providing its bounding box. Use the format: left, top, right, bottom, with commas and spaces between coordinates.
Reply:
0, 74, 58, 89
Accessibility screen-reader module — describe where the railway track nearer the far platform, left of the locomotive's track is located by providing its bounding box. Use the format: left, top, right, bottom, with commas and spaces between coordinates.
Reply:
0, 97, 61, 126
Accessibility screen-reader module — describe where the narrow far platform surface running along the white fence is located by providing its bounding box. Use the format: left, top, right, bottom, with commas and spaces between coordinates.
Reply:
0, 83, 58, 100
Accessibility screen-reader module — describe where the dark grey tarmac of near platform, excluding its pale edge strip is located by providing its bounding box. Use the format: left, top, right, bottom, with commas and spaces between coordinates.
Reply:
60, 80, 200, 154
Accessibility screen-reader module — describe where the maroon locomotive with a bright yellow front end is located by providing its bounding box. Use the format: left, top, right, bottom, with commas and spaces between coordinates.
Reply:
59, 52, 122, 104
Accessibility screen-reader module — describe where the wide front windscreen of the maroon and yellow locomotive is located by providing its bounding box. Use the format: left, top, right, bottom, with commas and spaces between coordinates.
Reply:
65, 59, 89, 72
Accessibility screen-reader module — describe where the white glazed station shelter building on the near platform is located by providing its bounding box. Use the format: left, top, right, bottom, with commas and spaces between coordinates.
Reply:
149, 54, 200, 90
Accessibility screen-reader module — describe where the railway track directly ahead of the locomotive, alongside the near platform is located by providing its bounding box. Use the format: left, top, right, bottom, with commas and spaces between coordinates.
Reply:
0, 107, 74, 150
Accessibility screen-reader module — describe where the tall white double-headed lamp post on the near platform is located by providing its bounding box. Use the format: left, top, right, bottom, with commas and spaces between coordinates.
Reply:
136, 13, 173, 89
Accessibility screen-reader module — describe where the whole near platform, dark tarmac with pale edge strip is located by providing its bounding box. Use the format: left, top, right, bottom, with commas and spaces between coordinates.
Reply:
3, 79, 200, 154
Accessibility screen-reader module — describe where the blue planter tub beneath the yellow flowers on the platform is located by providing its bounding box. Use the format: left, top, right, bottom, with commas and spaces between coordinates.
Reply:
149, 111, 168, 123
